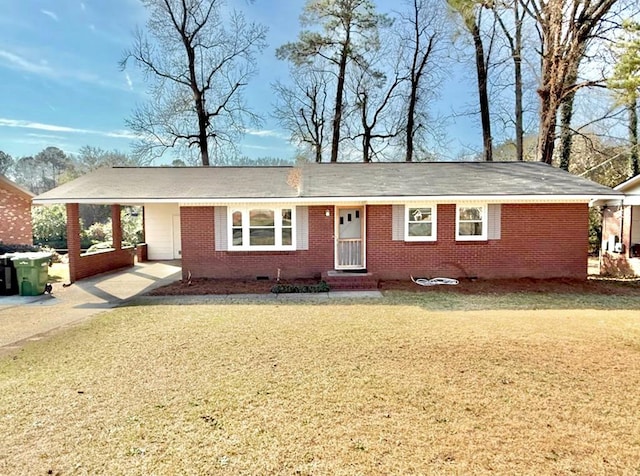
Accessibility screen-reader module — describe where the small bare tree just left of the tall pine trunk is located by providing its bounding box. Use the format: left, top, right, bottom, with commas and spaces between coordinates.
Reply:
273, 67, 329, 163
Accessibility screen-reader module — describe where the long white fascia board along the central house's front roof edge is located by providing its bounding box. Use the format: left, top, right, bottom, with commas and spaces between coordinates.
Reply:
33, 194, 623, 206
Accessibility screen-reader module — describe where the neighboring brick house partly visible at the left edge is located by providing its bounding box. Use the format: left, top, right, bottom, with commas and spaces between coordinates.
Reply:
0, 174, 33, 245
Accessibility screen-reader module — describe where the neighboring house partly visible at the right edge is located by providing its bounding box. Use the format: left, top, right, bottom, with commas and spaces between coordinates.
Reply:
600, 175, 640, 276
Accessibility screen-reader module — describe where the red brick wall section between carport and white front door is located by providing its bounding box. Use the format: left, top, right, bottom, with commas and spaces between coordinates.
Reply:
180, 207, 333, 279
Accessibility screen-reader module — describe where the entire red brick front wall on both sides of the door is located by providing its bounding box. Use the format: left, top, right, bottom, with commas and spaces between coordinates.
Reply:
180, 204, 588, 279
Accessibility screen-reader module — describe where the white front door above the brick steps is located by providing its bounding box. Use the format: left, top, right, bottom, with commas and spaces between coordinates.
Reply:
335, 207, 365, 269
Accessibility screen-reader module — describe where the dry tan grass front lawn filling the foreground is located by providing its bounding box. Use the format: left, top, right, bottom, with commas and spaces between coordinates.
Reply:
0, 304, 640, 475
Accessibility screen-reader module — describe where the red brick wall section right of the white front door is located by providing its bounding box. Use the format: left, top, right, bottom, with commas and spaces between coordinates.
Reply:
367, 204, 588, 279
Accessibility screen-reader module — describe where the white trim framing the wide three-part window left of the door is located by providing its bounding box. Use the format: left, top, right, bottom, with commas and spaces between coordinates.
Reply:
227, 204, 297, 251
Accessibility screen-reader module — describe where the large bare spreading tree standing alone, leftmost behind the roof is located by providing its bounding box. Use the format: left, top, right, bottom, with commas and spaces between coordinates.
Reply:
121, 0, 266, 166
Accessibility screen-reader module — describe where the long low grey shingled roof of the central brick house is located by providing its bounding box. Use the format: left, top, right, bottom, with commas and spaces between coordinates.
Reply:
34, 162, 621, 204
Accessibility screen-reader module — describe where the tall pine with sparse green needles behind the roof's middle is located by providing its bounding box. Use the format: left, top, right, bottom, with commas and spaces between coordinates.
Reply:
276, 0, 390, 162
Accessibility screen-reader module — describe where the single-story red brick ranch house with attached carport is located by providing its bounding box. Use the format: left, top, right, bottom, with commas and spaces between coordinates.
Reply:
34, 162, 620, 280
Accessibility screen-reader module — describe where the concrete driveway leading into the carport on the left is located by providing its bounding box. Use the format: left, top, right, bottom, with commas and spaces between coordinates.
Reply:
0, 261, 181, 355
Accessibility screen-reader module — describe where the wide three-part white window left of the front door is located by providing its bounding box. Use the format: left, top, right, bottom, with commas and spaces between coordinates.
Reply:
229, 207, 294, 250
